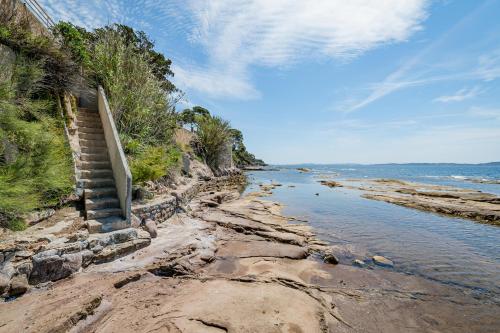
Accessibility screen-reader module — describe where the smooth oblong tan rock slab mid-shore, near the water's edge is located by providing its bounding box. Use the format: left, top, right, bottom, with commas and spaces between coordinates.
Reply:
216, 241, 308, 259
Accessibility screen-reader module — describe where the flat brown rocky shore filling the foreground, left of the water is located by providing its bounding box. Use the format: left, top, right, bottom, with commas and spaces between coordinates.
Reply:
0, 174, 500, 333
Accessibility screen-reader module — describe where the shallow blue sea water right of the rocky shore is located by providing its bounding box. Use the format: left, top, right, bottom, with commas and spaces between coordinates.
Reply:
247, 164, 500, 302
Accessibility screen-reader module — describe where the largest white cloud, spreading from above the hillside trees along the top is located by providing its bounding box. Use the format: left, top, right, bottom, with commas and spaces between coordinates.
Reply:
41, 0, 428, 99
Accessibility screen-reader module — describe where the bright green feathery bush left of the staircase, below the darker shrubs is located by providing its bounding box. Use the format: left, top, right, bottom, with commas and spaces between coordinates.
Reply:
0, 55, 74, 230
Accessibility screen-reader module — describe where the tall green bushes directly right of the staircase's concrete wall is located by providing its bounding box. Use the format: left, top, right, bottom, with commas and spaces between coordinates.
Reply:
54, 22, 180, 183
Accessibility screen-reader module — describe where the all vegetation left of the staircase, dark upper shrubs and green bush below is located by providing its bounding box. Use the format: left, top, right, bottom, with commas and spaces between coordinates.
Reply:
0, 25, 74, 230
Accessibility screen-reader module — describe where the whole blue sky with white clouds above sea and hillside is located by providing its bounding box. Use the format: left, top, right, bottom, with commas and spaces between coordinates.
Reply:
40, 0, 500, 164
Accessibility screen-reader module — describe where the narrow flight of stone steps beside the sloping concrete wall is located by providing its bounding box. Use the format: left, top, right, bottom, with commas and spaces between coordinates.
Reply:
77, 108, 126, 232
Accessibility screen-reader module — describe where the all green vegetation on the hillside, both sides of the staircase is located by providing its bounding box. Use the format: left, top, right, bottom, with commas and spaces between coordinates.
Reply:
0, 14, 264, 230
